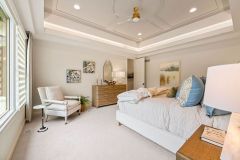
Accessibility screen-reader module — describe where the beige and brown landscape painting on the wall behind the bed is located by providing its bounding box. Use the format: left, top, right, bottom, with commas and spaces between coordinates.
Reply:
160, 62, 180, 87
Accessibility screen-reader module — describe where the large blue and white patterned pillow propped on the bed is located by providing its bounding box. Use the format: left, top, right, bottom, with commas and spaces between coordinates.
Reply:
176, 75, 204, 107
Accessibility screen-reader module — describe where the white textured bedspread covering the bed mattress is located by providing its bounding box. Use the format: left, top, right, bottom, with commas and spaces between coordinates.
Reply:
118, 96, 230, 139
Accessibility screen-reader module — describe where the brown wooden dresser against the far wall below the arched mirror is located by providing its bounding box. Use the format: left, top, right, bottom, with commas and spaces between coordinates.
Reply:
92, 84, 127, 107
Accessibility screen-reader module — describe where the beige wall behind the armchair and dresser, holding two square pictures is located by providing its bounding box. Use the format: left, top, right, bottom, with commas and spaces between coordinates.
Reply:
33, 40, 127, 104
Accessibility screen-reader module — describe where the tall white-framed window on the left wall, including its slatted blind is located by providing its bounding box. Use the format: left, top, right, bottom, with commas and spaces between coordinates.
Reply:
0, 1, 27, 126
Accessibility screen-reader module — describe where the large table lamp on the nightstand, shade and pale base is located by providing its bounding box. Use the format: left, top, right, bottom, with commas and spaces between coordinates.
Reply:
204, 64, 240, 160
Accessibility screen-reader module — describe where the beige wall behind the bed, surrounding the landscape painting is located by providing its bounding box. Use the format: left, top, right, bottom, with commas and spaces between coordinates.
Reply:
146, 38, 240, 87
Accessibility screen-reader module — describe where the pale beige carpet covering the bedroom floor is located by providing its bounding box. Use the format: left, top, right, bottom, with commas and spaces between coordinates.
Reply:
13, 106, 175, 160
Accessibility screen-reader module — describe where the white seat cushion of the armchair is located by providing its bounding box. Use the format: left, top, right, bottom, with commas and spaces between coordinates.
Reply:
45, 100, 80, 111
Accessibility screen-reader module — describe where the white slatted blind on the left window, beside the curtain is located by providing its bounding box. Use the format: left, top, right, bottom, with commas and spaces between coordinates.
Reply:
16, 27, 26, 108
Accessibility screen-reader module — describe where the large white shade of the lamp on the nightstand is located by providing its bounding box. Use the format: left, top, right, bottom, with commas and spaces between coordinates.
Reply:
204, 64, 240, 113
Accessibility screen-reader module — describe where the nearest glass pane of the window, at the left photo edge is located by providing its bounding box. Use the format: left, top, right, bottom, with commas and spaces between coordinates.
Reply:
0, 7, 9, 117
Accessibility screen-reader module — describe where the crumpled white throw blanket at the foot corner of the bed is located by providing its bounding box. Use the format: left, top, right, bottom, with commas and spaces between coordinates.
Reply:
117, 88, 149, 103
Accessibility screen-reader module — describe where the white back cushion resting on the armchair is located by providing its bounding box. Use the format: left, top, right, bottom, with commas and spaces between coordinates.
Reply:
46, 86, 64, 101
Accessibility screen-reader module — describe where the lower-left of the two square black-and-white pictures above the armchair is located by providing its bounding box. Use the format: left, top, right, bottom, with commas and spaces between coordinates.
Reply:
66, 69, 81, 83
